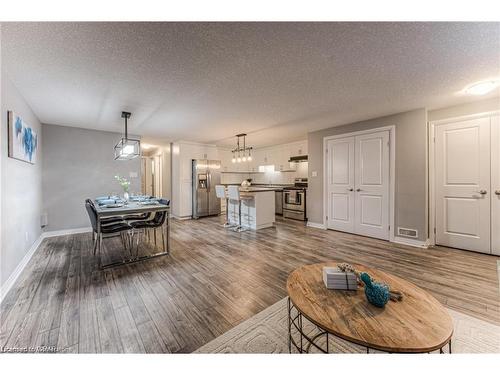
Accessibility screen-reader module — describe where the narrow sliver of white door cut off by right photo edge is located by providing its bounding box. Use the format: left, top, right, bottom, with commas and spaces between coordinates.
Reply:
490, 116, 500, 255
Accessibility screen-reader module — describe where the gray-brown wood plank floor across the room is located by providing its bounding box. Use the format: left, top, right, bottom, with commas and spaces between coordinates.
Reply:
0, 218, 500, 353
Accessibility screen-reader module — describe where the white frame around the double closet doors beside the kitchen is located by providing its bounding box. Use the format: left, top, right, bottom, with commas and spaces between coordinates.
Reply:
323, 125, 396, 242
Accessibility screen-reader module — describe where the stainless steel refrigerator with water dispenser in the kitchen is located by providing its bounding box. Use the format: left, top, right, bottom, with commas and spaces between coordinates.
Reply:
192, 159, 221, 219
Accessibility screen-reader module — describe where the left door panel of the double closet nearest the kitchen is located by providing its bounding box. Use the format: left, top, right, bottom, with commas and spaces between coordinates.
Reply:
326, 137, 354, 233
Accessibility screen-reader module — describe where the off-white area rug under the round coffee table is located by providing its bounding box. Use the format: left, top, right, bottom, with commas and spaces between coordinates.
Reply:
195, 298, 500, 353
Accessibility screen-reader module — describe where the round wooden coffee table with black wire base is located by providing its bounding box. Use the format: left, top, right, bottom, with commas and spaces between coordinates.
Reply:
287, 262, 453, 353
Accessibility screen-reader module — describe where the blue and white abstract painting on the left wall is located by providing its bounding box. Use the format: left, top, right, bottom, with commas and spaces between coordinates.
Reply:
8, 111, 38, 164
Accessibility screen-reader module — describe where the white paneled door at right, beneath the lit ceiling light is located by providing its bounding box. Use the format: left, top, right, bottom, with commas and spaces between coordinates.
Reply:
435, 118, 491, 253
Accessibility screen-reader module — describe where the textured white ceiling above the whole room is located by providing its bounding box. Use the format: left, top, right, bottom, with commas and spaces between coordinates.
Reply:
2, 22, 500, 146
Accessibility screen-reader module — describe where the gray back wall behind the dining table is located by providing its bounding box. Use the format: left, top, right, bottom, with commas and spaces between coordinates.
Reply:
42, 124, 141, 231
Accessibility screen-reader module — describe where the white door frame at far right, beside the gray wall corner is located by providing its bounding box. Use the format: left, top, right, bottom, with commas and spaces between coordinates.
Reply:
427, 111, 500, 246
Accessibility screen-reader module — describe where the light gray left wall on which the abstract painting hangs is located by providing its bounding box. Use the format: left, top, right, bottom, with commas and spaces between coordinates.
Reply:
0, 72, 44, 286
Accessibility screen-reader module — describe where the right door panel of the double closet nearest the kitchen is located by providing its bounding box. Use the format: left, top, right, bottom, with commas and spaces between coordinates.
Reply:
354, 131, 390, 240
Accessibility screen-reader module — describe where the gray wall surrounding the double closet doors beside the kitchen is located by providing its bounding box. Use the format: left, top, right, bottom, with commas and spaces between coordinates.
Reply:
307, 109, 428, 241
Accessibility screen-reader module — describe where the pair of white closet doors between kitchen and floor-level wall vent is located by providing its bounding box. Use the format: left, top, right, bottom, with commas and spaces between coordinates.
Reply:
326, 131, 390, 239
